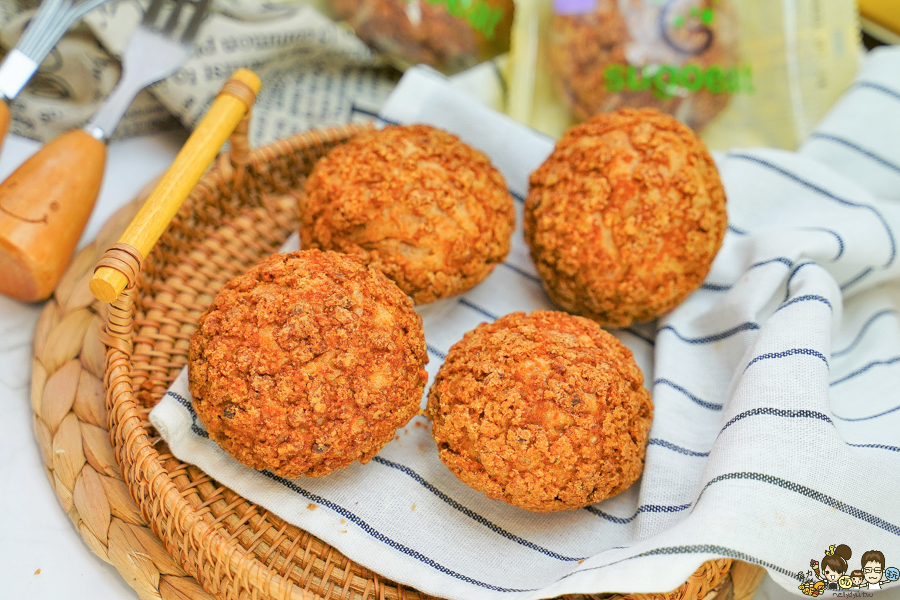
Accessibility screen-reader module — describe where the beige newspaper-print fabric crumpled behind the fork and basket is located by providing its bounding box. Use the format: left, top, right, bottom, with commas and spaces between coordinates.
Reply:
0, 0, 397, 145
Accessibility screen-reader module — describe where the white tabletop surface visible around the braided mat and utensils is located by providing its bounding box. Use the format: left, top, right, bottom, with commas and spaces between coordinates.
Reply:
0, 132, 900, 600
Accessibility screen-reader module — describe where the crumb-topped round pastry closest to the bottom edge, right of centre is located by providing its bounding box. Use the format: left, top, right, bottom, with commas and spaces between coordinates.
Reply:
427, 311, 653, 512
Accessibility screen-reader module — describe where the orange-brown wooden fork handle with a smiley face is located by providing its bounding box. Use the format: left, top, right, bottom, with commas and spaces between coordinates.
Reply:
0, 129, 106, 301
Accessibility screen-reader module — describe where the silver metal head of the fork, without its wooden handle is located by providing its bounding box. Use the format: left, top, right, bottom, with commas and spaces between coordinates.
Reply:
84, 0, 209, 140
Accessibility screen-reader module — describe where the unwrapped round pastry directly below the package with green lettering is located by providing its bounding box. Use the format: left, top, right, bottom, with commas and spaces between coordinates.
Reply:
525, 109, 727, 327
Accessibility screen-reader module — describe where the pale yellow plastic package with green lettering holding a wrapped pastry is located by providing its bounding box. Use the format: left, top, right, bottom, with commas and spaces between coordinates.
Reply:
507, 0, 860, 149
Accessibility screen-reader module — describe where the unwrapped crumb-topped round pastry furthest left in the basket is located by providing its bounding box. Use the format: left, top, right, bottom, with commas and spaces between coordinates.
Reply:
188, 250, 428, 478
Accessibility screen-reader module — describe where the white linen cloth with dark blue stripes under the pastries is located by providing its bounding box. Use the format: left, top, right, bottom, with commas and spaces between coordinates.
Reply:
151, 48, 900, 600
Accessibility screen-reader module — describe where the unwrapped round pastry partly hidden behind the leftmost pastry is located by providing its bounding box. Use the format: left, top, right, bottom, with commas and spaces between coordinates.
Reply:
299, 125, 515, 304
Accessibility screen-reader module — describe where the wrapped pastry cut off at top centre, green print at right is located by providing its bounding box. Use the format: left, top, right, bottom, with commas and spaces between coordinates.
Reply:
327, 0, 514, 74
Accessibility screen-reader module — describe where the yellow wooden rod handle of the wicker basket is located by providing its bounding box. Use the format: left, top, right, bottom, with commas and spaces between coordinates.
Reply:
90, 69, 260, 302
